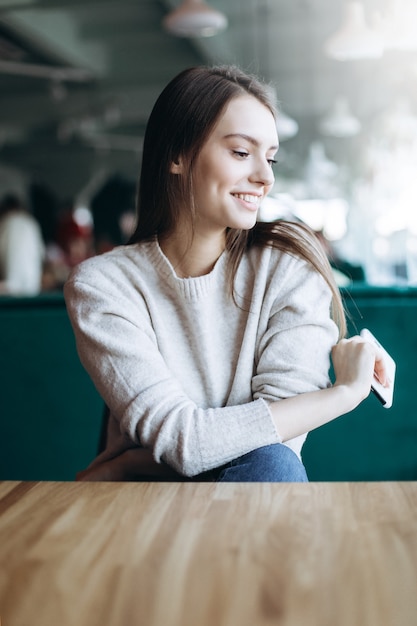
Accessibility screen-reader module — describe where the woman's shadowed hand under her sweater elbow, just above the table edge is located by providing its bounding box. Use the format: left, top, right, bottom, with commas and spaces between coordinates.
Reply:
76, 448, 182, 482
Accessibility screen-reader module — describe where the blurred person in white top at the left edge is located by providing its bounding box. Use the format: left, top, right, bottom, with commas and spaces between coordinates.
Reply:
0, 194, 45, 295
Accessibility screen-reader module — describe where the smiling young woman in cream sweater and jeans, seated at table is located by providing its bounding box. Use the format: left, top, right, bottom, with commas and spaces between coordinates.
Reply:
65, 67, 385, 481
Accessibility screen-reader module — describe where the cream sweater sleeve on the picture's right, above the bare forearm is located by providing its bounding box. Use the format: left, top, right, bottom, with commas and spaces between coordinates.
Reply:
252, 260, 338, 401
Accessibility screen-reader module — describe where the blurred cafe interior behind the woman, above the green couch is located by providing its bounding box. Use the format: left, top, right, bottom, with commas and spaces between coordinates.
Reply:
0, 0, 417, 285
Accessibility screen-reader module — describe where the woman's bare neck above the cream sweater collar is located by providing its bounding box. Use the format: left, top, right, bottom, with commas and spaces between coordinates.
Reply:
159, 232, 226, 278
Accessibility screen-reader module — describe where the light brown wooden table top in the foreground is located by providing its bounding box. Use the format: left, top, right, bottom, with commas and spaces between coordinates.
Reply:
0, 482, 417, 626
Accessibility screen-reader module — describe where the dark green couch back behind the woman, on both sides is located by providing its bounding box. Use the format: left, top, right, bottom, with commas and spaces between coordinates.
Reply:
0, 286, 417, 481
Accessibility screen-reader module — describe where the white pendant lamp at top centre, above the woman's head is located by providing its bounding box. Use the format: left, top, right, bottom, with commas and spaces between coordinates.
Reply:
162, 0, 228, 37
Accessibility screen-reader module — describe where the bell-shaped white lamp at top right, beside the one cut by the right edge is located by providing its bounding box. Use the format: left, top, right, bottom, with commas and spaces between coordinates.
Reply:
324, 2, 384, 61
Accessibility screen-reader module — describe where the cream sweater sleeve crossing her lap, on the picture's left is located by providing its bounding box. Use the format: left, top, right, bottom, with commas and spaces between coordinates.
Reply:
65, 273, 280, 476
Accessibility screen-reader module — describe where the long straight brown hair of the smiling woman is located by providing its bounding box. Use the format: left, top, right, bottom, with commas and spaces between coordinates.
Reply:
129, 66, 346, 336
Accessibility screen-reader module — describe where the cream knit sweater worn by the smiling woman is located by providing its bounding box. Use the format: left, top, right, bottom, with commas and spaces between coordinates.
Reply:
65, 239, 337, 476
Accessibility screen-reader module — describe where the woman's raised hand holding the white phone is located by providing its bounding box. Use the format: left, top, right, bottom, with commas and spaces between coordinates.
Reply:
332, 336, 389, 403
